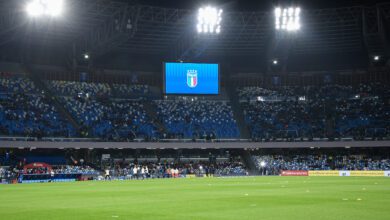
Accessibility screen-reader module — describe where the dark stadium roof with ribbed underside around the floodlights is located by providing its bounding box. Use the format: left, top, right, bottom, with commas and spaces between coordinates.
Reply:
0, 0, 390, 63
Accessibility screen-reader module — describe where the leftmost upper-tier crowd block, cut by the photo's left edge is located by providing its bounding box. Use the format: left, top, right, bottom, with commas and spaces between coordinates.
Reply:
0, 77, 75, 138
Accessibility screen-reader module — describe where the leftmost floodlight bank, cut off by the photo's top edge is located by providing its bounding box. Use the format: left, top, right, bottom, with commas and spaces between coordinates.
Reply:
26, 0, 64, 17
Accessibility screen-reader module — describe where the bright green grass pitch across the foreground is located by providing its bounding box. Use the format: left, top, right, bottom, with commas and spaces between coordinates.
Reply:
0, 177, 390, 220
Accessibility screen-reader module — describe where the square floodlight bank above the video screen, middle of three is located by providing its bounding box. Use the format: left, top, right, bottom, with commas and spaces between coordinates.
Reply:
196, 6, 223, 34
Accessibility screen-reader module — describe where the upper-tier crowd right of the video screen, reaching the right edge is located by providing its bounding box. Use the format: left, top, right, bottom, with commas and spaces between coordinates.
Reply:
238, 84, 390, 140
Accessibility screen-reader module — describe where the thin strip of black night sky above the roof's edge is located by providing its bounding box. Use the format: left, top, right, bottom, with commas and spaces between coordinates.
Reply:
127, 0, 389, 11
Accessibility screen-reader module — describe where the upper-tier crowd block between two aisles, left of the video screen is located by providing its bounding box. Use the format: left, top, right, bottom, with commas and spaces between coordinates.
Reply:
46, 81, 157, 141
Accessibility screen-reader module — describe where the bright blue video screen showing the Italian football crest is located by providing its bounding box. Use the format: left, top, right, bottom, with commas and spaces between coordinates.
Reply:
164, 63, 219, 95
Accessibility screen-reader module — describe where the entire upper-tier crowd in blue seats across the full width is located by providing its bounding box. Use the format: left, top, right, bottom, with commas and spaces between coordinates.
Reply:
0, 74, 390, 141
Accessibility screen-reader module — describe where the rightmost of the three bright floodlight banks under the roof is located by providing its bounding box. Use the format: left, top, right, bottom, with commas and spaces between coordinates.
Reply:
274, 7, 301, 32
